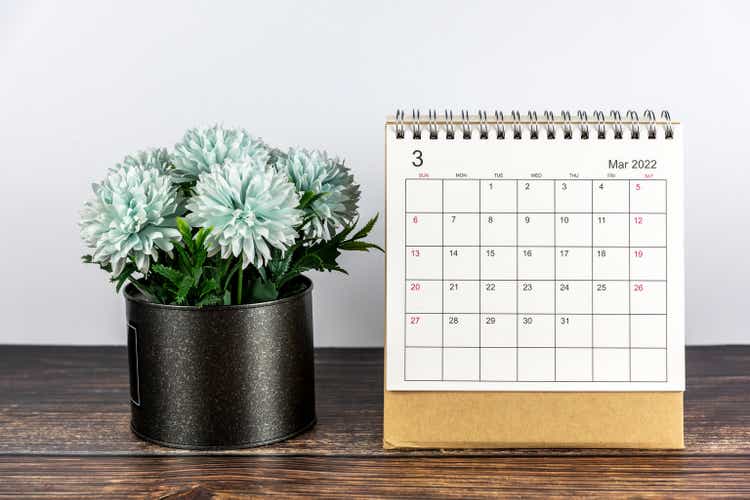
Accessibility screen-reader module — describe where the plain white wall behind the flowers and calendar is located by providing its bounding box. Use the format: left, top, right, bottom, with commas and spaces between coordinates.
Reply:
0, 0, 750, 346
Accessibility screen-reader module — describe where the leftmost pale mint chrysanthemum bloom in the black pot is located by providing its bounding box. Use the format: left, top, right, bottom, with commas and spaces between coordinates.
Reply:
80, 163, 180, 276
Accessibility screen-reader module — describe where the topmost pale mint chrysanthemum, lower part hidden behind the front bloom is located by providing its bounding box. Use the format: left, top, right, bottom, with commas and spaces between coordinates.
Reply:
172, 125, 269, 182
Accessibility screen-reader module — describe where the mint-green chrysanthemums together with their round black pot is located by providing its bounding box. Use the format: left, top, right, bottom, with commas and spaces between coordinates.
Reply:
80, 126, 382, 449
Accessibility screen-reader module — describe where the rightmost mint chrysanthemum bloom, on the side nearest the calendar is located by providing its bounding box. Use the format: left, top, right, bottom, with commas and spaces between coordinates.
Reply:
274, 149, 360, 239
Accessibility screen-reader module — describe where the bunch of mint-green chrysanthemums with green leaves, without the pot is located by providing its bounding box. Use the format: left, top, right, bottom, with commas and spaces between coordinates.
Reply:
81, 126, 380, 306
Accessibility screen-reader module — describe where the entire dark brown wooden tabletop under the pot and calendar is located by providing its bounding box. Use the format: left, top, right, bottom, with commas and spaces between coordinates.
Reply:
0, 346, 750, 498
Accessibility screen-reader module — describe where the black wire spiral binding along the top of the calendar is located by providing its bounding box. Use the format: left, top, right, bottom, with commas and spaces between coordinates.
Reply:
394, 109, 674, 140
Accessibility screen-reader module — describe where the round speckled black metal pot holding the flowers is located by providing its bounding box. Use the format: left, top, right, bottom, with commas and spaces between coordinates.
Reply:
125, 277, 315, 449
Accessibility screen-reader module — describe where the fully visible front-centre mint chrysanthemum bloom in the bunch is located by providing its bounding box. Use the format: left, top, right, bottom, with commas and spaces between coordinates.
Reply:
187, 158, 302, 268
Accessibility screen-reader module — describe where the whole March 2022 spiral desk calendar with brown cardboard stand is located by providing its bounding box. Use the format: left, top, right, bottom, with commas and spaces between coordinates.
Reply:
384, 112, 684, 448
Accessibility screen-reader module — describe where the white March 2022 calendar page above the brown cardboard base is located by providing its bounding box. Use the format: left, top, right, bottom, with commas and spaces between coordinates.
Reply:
386, 115, 685, 391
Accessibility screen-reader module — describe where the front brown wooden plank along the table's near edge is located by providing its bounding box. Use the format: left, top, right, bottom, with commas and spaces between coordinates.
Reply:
0, 456, 750, 498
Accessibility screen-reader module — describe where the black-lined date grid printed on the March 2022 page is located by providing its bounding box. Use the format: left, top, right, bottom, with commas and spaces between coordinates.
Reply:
403, 178, 668, 382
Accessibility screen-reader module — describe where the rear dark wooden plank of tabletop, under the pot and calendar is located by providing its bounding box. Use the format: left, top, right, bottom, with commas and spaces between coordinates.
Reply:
0, 346, 750, 456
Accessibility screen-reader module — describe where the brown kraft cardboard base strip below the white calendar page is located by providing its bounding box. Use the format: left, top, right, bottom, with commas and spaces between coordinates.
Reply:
383, 391, 685, 449
